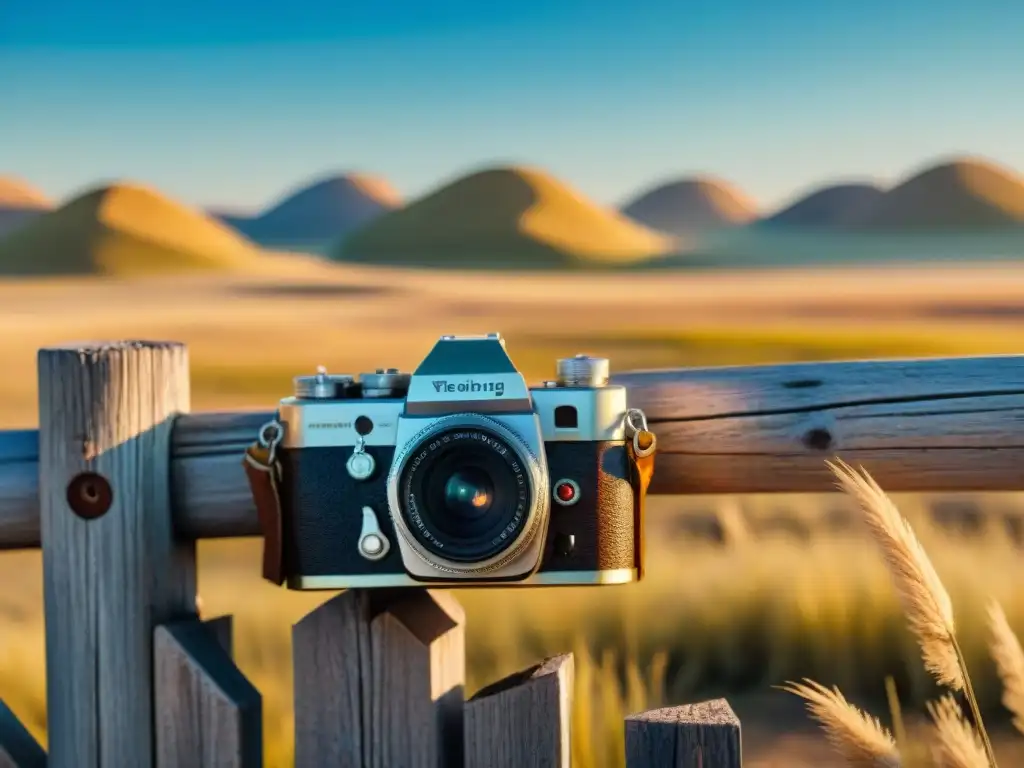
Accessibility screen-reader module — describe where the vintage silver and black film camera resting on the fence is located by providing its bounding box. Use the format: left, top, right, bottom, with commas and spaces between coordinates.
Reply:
278, 334, 642, 590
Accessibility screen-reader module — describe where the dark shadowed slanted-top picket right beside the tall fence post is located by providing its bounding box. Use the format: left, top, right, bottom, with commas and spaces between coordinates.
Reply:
154, 616, 263, 768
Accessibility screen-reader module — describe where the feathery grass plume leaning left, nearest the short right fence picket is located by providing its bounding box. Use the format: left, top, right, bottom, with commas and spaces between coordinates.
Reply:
779, 678, 900, 768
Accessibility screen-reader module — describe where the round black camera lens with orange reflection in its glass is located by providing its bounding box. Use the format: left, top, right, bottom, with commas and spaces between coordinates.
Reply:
398, 427, 532, 563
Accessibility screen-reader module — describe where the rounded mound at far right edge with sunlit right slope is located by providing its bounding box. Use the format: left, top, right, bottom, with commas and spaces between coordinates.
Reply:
851, 159, 1024, 230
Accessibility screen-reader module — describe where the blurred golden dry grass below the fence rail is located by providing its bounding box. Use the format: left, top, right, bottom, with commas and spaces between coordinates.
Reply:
0, 498, 1024, 768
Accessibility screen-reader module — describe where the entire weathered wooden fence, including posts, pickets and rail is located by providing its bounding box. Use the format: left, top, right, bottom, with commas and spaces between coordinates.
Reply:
0, 342, 1024, 768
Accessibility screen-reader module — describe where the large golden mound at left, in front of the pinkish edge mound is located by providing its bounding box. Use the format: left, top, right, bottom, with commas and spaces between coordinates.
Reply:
0, 183, 256, 275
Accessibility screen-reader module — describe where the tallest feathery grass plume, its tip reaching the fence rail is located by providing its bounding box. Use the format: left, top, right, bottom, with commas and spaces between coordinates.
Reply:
825, 460, 965, 690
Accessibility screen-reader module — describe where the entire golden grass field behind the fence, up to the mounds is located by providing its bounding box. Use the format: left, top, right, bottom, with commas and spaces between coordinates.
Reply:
0, 257, 1024, 768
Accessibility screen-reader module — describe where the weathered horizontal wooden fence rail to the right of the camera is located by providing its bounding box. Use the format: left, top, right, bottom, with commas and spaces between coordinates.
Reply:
616, 356, 1024, 494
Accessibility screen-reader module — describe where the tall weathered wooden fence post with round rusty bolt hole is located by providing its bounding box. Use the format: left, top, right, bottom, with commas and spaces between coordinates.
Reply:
38, 342, 196, 768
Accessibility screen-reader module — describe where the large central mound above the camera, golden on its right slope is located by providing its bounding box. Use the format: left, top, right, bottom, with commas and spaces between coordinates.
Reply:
332, 168, 673, 268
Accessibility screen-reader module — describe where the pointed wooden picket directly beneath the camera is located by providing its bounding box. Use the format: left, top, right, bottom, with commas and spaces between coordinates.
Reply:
292, 589, 465, 768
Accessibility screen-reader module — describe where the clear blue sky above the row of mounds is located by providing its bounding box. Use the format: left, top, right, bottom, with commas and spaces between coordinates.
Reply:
0, 0, 1024, 207
